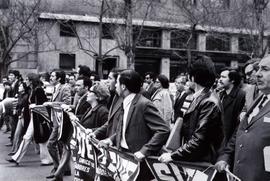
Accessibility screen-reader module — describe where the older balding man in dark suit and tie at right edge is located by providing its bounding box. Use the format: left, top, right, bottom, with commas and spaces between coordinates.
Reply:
216, 55, 270, 181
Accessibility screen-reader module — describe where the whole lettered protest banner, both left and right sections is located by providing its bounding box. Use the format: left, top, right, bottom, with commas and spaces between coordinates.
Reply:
67, 111, 240, 181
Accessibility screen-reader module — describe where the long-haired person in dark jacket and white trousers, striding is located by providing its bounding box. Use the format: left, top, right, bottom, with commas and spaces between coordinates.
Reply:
7, 73, 52, 166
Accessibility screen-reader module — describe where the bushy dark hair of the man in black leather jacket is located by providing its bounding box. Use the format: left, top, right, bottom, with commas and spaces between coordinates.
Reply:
189, 55, 216, 88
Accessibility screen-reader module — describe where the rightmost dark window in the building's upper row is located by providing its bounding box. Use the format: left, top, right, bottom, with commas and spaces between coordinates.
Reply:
238, 35, 258, 52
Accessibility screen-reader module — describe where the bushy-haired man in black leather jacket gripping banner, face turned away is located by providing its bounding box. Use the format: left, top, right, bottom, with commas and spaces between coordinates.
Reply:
159, 56, 223, 163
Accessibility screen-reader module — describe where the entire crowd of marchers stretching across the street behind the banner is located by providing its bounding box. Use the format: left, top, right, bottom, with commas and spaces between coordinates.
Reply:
0, 56, 270, 181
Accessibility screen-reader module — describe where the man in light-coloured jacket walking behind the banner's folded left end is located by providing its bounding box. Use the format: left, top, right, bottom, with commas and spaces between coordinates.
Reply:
44, 70, 71, 181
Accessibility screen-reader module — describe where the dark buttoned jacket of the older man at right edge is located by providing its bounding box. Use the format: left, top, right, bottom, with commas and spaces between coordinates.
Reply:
219, 96, 270, 181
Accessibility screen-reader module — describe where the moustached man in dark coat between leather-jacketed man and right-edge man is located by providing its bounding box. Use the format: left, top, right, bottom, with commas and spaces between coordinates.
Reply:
218, 68, 245, 144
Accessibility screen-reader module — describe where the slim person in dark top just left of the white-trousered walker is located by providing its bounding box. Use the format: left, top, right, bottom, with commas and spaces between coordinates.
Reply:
9, 82, 30, 155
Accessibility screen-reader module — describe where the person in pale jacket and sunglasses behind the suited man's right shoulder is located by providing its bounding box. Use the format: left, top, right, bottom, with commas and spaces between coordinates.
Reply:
151, 74, 173, 123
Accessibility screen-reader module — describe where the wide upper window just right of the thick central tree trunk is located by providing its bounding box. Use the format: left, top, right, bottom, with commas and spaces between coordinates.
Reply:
133, 27, 161, 47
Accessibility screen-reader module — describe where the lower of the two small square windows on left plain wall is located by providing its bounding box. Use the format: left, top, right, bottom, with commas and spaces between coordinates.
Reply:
59, 53, 76, 70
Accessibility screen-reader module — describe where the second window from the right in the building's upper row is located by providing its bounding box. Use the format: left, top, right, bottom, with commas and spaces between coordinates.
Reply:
206, 34, 231, 51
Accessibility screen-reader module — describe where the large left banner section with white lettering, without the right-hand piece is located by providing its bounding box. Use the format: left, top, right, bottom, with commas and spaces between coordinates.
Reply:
69, 111, 139, 181
